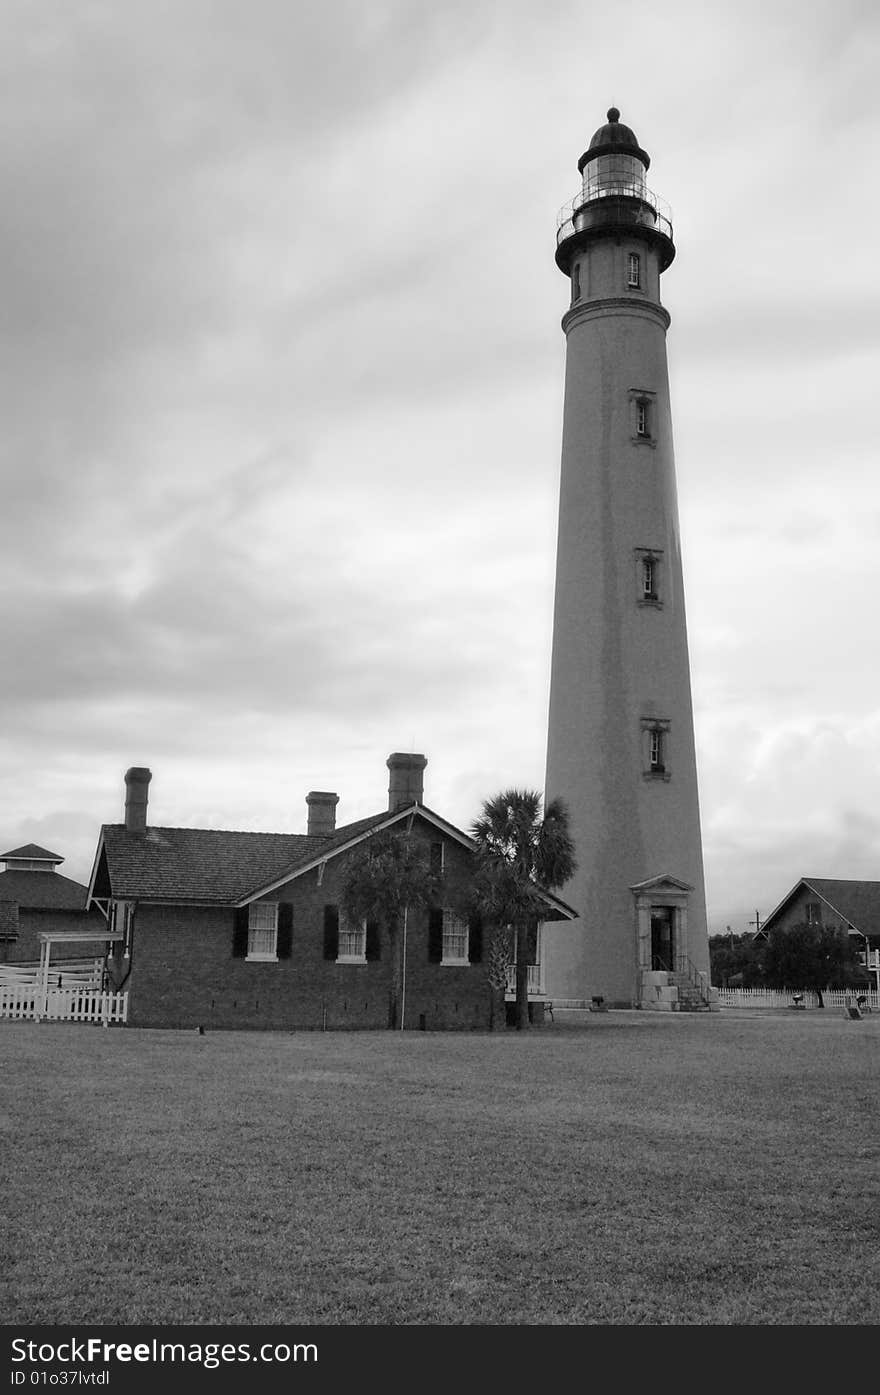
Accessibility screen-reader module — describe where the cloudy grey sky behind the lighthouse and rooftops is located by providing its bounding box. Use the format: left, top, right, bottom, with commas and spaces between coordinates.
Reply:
0, 0, 880, 930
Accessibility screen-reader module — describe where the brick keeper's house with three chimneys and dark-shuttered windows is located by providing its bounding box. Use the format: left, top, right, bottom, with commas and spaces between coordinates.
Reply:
89, 753, 575, 1031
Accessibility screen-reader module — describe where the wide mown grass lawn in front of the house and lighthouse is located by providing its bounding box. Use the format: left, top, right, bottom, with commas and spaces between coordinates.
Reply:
0, 1010, 880, 1325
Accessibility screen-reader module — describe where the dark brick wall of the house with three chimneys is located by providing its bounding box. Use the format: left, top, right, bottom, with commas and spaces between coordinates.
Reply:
122, 833, 502, 1031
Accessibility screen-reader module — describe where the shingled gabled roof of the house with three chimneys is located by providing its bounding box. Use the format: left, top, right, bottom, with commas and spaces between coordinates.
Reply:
87, 804, 577, 919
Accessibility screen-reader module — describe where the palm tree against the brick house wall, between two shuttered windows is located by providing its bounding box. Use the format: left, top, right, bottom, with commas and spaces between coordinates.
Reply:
340, 831, 443, 1030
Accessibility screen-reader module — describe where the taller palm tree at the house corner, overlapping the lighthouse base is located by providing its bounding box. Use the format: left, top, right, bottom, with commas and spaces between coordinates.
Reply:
470, 790, 577, 1031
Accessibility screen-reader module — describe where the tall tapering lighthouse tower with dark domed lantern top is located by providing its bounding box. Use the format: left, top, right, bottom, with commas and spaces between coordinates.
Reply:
541, 107, 711, 1010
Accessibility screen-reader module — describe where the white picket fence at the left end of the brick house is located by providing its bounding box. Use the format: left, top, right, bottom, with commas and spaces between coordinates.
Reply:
0, 960, 128, 1025
